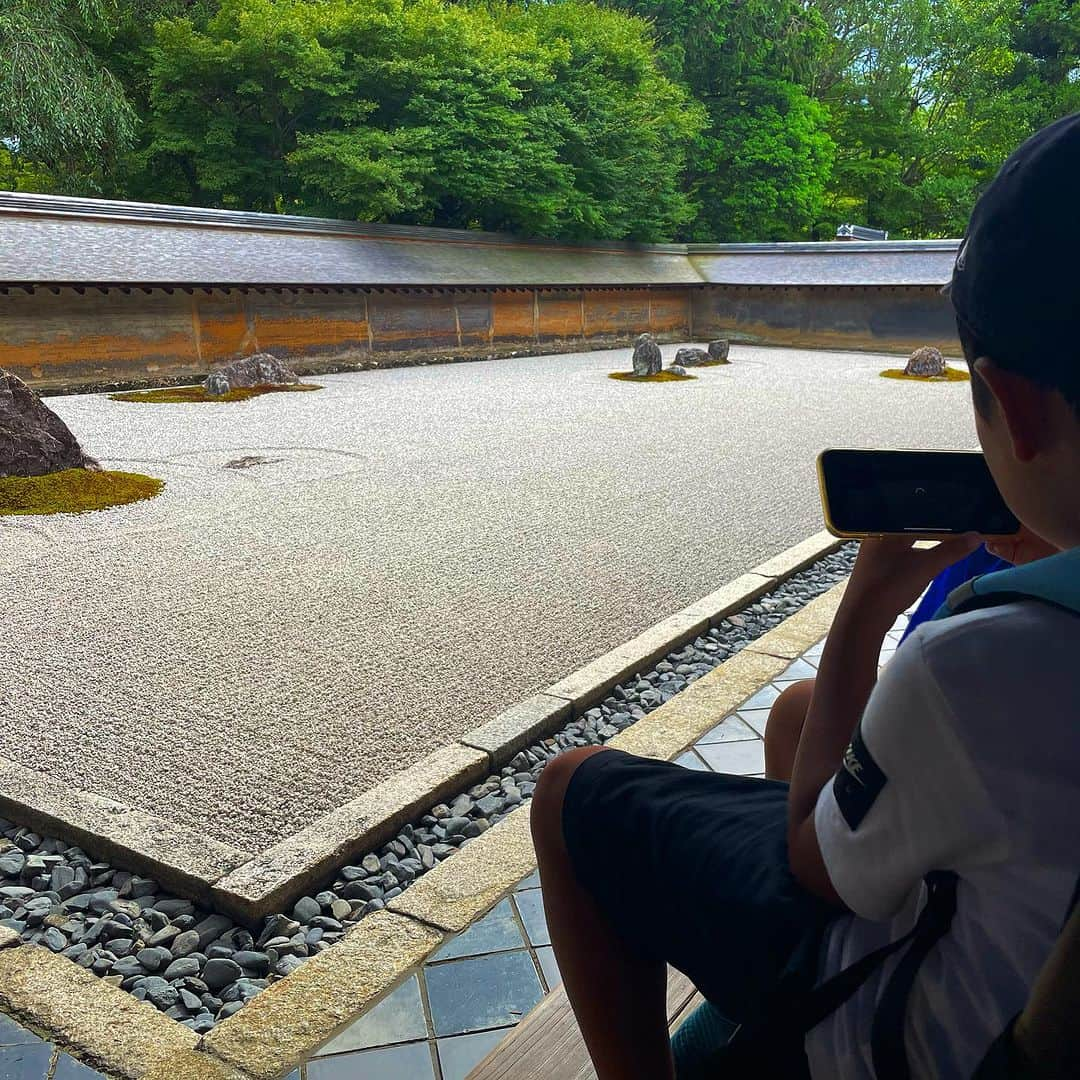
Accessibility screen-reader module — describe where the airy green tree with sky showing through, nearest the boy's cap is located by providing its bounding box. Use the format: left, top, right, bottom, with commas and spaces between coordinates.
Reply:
810, 0, 1078, 238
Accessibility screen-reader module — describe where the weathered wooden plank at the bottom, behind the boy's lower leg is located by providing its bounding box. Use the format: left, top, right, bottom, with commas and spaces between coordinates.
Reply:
469, 968, 698, 1080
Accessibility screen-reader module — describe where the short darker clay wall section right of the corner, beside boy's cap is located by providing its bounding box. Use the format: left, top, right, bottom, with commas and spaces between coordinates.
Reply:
692, 285, 960, 355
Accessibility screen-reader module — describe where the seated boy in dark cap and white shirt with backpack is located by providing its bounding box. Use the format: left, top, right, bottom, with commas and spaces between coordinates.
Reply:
532, 114, 1080, 1080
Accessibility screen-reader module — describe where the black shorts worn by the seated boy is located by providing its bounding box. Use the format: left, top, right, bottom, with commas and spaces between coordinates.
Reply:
563, 751, 837, 1024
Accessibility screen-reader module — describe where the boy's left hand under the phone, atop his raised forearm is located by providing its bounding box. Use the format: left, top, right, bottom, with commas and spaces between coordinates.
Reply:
843, 532, 982, 623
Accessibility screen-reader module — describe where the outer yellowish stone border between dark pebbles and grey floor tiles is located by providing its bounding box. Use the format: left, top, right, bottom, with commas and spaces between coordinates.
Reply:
0, 559, 843, 1080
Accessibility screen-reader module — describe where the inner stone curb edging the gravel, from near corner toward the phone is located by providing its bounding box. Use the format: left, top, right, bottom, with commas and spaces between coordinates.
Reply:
210, 531, 843, 926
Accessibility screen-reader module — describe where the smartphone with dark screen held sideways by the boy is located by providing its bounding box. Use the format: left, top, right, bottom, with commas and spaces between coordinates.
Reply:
818, 449, 1020, 540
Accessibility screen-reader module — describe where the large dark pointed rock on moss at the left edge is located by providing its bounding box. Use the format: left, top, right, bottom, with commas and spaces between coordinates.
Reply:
0, 369, 97, 476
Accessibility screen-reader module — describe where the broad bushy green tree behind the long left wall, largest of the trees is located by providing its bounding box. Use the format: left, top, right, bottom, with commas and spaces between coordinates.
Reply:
133, 0, 702, 239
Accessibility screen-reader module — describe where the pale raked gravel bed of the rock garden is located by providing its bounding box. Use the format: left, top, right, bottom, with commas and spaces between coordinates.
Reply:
0, 347, 974, 876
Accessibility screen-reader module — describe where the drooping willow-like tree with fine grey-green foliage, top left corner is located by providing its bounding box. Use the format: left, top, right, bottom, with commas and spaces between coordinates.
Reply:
0, 0, 135, 190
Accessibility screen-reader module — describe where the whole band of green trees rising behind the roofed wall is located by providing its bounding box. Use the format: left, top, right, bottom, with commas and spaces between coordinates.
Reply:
0, 0, 1080, 241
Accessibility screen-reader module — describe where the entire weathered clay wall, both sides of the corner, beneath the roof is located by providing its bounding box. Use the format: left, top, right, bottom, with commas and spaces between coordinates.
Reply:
0, 285, 956, 390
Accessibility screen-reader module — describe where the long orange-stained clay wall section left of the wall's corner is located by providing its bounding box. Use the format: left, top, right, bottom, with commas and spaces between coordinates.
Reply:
0, 286, 690, 389
